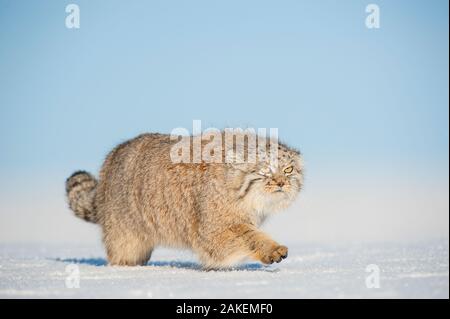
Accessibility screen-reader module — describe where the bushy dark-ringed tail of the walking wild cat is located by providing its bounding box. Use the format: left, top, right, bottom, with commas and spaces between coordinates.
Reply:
66, 171, 97, 223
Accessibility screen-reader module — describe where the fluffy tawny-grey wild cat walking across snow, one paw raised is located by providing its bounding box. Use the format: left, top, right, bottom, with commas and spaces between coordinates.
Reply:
66, 134, 303, 268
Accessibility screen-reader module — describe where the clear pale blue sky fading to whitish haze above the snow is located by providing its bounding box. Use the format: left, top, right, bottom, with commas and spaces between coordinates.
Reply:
0, 0, 449, 245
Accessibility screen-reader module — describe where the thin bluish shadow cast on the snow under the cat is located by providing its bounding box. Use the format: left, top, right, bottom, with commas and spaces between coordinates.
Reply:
54, 258, 277, 272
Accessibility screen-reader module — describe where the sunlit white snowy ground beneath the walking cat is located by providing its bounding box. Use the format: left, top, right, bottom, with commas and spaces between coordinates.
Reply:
0, 239, 449, 298
